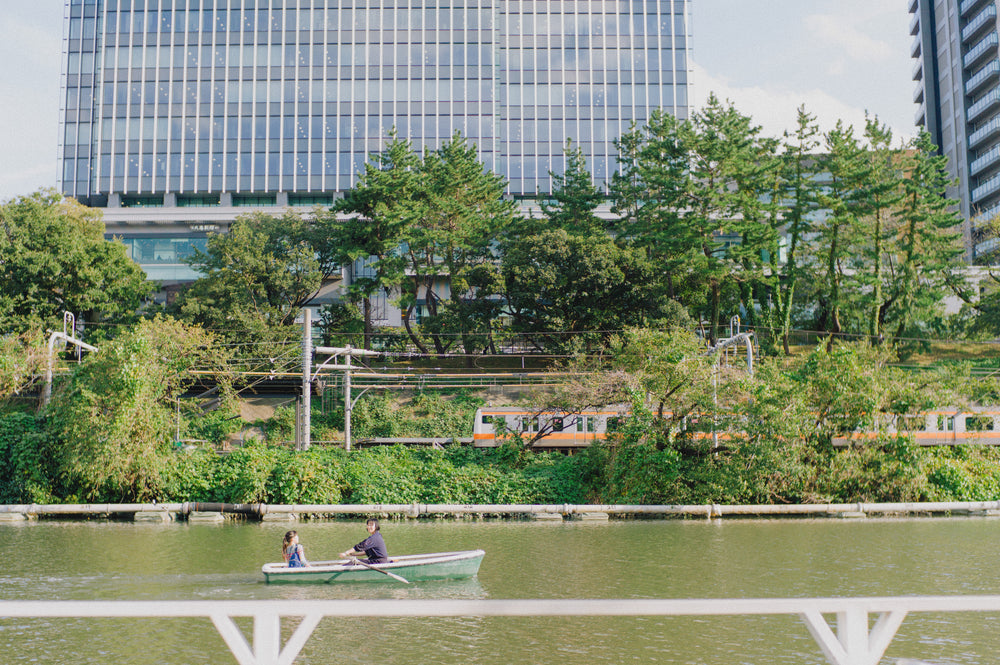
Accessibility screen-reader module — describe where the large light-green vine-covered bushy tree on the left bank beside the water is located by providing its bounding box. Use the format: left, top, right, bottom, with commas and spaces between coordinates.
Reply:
47, 318, 227, 502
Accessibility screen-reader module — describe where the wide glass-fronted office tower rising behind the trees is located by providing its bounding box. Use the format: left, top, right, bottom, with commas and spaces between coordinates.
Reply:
60, 0, 692, 282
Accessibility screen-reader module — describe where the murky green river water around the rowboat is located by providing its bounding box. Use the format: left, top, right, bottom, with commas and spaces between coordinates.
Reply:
0, 517, 1000, 665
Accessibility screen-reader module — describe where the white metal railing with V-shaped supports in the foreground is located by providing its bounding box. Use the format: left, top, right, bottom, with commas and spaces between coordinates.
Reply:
0, 596, 1000, 665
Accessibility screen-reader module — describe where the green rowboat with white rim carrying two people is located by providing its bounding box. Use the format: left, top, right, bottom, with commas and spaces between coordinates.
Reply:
261, 550, 486, 584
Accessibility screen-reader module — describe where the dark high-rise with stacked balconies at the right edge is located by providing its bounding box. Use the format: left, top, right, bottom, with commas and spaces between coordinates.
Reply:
909, 0, 1000, 258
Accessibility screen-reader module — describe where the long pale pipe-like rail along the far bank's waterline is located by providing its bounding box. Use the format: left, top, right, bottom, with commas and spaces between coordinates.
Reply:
0, 501, 1000, 518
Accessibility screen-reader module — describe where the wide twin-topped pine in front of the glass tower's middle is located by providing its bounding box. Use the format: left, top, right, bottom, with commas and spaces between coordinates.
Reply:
337, 132, 517, 353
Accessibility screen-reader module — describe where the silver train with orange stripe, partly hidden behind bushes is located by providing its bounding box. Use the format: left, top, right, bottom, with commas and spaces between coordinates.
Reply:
472, 406, 1000, 450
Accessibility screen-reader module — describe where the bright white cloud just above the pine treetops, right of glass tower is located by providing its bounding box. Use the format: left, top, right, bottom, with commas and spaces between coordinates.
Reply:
692, 63, 915, 142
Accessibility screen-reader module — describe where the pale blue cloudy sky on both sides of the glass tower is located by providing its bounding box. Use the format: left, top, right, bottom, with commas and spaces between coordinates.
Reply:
0, 0, 916, 201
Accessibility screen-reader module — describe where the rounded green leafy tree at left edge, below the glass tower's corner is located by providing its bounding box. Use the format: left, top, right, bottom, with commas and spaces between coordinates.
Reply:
0, 190, 153, 332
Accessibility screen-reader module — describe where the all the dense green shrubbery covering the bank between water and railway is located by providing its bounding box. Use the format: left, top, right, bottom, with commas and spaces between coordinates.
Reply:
9, 320, 1000, 504
